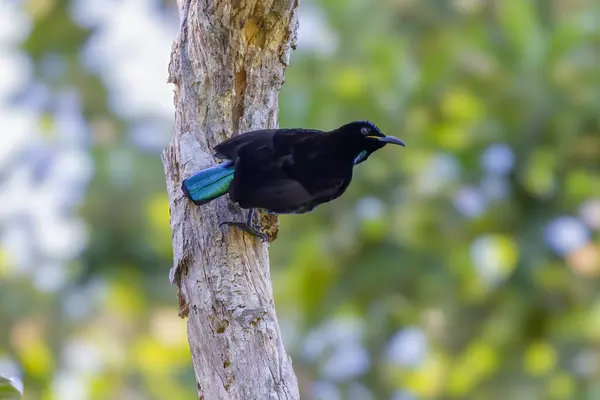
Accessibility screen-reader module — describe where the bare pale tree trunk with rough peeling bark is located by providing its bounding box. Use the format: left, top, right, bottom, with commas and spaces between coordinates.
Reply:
163, 0, 299, 400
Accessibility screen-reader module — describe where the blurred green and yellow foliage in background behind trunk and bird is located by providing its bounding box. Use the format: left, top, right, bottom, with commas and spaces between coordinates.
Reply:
0, 0, 600, 400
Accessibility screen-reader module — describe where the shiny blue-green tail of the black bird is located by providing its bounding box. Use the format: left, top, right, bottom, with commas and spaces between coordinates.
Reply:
181, 161, 235, 205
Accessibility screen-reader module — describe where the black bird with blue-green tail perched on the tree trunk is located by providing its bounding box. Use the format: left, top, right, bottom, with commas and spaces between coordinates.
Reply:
182, 121, 405, 240
